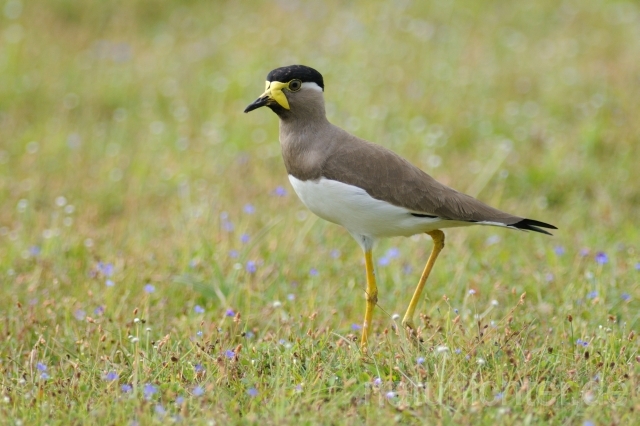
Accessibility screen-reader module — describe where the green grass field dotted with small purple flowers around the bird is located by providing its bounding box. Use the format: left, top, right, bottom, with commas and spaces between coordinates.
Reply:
0, 0, 640, 425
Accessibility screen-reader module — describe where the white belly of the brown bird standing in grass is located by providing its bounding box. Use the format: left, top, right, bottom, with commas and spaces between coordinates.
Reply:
289, 175, 458, 238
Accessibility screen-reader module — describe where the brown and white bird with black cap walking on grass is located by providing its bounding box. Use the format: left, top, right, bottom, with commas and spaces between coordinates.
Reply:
244, 65, 558, 351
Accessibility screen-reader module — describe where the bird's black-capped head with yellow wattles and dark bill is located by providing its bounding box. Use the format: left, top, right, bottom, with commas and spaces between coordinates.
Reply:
244, 65, 324, 118
